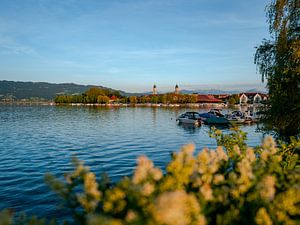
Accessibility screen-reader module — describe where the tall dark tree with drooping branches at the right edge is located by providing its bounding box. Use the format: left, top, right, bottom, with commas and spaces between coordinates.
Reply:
254, 0, 300, 137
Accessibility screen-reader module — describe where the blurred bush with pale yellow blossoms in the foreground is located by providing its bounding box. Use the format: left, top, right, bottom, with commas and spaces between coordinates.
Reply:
0, 130, 300, 225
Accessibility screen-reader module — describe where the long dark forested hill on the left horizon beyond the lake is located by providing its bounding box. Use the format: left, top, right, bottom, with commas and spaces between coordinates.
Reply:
0, 80, 127, 100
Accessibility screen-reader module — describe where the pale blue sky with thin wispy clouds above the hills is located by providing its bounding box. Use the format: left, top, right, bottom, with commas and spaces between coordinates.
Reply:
0, 0, 270, 92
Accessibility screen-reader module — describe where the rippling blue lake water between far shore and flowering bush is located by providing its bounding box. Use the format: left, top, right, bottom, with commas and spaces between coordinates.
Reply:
0, 106, 263, 218
